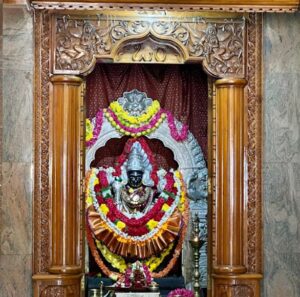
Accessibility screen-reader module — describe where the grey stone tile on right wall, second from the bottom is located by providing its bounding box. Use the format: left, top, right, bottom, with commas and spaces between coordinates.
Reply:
264, 163, 300, 255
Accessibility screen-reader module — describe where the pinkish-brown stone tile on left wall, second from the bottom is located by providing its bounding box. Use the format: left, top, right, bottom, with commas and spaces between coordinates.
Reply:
0, 163, 33, 255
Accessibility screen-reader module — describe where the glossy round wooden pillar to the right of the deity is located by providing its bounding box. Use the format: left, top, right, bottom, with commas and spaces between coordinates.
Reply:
213, 78, 246, 276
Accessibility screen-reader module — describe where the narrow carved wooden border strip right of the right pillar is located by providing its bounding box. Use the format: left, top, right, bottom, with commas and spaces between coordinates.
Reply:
245, 14, 262, 273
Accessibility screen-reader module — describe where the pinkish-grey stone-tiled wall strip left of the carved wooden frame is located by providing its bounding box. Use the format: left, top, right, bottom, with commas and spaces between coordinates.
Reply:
0, 5, 33, 297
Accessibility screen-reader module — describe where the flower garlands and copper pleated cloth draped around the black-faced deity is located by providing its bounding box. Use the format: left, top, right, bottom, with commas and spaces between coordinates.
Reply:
86, 138, 189, 277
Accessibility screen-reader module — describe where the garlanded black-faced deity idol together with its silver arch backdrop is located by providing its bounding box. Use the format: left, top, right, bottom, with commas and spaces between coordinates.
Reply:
86, 90, 207, 281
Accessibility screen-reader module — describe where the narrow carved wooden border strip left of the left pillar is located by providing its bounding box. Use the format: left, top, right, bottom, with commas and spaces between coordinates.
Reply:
33, 12, 51, 273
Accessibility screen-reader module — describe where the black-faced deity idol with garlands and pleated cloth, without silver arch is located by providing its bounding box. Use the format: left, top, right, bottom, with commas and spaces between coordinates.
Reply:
86, 138, 188, 277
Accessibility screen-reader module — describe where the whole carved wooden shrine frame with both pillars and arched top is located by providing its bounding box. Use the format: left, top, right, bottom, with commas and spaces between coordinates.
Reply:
33, 4, 262, 297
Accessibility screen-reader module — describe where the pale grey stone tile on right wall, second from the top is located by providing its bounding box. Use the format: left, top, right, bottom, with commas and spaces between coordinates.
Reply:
264, 73, 300, 162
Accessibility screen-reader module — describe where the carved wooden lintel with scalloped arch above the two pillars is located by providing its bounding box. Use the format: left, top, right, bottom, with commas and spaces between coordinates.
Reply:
53, 14, 245, 77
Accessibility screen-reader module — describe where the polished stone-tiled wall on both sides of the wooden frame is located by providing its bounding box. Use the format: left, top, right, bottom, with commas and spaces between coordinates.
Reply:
0, 6, 300, 297
